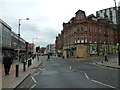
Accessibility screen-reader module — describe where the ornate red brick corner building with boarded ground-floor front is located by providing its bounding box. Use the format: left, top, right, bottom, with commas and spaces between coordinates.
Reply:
55, 10, 118, 58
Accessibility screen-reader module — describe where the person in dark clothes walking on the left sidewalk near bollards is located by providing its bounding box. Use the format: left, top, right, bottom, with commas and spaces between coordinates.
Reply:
3, 54, 12, 76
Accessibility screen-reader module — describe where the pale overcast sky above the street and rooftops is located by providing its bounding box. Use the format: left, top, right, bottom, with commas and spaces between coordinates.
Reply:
0, 0, 119, 47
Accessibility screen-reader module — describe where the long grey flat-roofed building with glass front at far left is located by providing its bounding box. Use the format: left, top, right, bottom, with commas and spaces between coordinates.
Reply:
0, 19, 27, 59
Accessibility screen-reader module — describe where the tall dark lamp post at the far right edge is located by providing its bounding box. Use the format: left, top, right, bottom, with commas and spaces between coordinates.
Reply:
113, 0, 120, 65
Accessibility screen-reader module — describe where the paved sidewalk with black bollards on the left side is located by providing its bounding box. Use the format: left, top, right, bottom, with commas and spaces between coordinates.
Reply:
2, 59, 42, 88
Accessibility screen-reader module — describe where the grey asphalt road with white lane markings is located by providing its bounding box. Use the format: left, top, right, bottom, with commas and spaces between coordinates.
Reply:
17, 56, 119, 89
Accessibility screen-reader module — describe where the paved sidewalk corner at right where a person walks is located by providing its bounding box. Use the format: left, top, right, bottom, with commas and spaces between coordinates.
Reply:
96, 57, 120, 69
